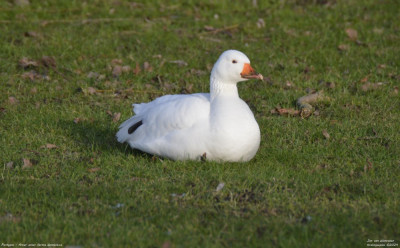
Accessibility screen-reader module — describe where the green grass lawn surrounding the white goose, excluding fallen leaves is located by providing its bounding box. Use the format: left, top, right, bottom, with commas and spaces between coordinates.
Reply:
0, 0, 400, 247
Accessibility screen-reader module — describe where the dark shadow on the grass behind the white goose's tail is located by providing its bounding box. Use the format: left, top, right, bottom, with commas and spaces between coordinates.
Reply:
58, 120, 152, 159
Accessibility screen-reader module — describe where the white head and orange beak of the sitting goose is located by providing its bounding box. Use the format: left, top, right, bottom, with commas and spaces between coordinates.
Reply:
211, 50, 263, 84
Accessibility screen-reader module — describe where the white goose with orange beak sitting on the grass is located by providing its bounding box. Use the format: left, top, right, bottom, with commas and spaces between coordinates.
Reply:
116, 50, 262, 162
